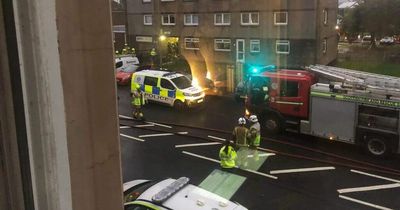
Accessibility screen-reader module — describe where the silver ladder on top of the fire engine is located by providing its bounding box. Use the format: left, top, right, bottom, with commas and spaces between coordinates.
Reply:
307, 65, 400, 98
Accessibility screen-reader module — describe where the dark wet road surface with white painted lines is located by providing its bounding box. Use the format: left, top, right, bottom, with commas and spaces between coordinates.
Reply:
118, 87, 400, 210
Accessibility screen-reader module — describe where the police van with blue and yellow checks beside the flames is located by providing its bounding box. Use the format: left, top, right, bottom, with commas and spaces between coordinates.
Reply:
131, 70, 205, 109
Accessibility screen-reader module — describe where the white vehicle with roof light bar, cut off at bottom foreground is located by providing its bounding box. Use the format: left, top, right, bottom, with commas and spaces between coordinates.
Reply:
123, 177, 247, 210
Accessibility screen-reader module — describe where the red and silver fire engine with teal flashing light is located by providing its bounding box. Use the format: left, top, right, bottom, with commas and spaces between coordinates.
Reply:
246, 65, 400, 156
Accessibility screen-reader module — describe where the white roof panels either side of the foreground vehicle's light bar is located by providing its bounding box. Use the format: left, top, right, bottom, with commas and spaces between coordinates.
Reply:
138, 179, 246, 210
